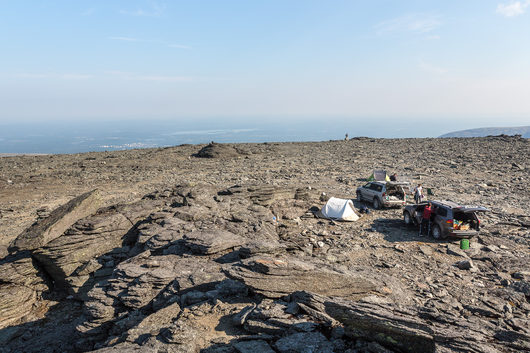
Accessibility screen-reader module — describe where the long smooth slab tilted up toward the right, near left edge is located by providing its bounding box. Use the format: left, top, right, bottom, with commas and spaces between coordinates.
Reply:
10, 190, 101, 252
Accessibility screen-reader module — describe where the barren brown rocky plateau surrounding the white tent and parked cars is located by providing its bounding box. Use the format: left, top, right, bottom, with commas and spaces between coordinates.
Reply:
0, 136, 530, 353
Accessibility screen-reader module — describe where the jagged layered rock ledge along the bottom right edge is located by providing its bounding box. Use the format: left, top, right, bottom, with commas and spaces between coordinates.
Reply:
293, 292, 530, 353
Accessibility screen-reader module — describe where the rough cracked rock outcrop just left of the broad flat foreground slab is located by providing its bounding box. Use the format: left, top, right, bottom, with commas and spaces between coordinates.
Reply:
79, 251, 226, 332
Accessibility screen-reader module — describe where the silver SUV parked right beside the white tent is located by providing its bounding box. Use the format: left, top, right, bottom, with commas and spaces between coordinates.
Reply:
356, 181, 410, 210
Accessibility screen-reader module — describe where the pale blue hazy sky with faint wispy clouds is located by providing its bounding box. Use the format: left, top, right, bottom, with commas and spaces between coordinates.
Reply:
0, 0, 530, 126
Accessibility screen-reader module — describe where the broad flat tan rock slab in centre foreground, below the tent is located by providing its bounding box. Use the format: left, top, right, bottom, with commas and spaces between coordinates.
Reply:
227, 256, 379, 300
